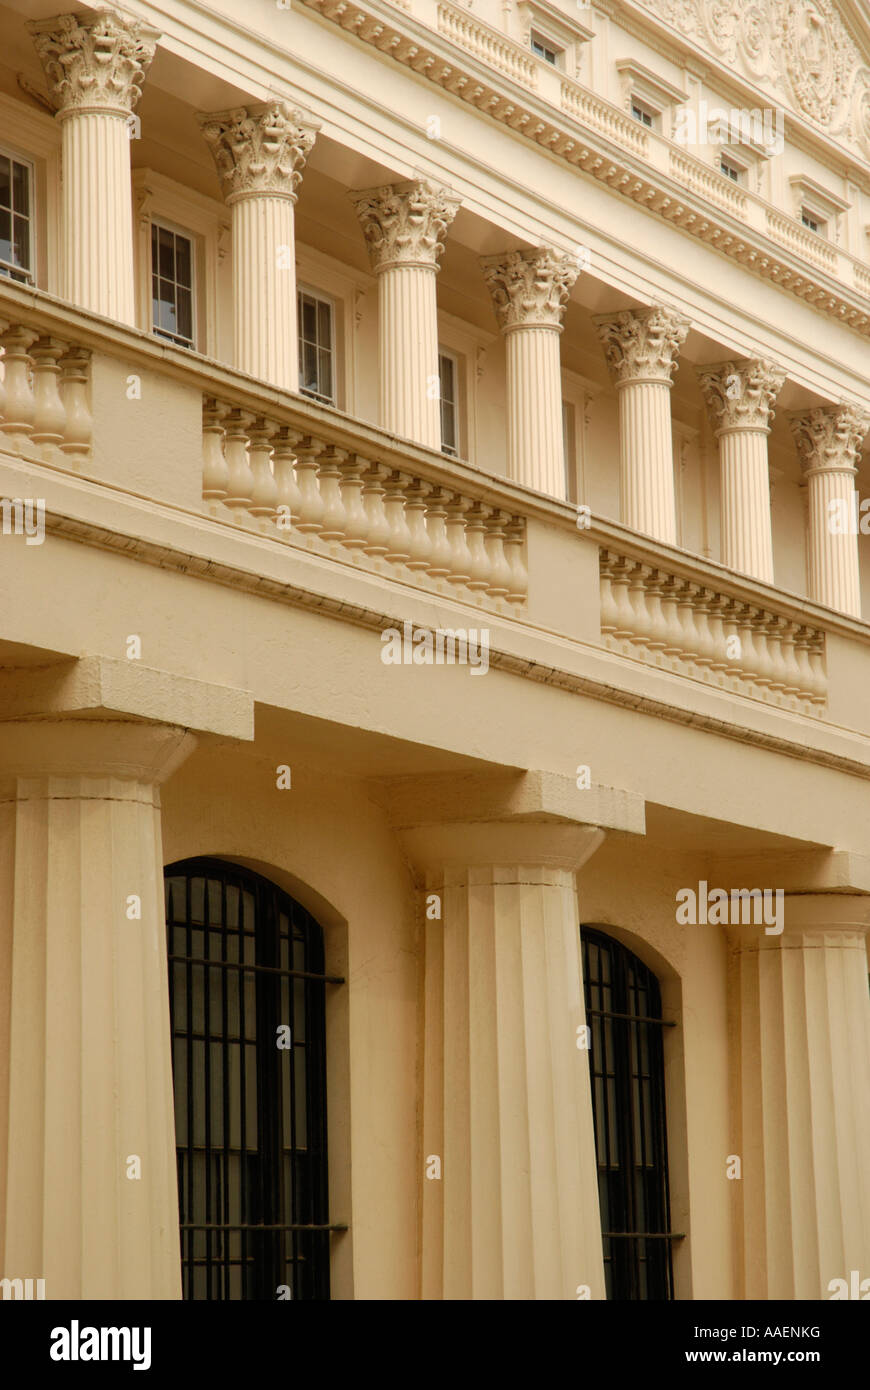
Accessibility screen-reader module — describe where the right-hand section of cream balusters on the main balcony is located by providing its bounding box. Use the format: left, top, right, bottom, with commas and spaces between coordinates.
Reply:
599, 549, 827, 714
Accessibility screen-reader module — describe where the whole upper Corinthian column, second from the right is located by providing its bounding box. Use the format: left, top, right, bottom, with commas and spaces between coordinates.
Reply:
698, 357, 785, 584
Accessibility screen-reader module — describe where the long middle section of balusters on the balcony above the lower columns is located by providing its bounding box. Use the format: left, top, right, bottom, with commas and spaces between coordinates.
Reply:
203, 398, 528, 607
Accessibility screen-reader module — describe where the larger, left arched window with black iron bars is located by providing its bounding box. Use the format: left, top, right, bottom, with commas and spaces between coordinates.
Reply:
165, 859, 329, 1300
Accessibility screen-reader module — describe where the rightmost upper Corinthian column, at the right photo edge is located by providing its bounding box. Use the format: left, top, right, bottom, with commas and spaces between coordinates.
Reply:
791, 403, 870, 617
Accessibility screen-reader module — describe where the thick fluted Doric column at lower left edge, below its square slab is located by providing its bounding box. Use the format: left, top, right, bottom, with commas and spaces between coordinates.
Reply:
0, 719, 195, 1300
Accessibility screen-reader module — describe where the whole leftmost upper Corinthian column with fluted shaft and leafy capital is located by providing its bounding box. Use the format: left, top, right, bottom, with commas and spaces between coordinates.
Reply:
28, 10, 160, 324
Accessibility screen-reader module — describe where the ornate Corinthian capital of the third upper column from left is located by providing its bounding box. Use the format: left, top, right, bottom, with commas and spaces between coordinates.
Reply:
350, 179, 460, 272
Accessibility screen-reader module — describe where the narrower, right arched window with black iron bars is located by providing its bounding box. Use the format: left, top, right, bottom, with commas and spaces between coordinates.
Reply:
581, 927, 673, 1300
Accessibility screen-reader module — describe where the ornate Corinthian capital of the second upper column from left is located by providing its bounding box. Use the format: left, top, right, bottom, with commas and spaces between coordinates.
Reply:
197, 101, 320, 203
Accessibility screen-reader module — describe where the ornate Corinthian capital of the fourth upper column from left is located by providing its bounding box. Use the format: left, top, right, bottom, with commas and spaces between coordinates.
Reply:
481, 246, 580, 332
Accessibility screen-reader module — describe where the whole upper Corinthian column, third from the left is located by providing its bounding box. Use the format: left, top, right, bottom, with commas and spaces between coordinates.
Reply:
350, 179, 459, 449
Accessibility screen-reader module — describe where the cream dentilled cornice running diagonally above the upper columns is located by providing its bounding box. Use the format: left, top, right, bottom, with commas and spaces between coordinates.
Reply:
297, 0, 870, 336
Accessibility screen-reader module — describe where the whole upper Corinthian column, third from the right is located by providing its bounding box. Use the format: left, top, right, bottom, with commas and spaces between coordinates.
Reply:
595, 304, 689, 545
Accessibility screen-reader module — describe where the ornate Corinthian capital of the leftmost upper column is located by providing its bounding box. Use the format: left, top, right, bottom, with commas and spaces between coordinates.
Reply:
28, 10, 160, 117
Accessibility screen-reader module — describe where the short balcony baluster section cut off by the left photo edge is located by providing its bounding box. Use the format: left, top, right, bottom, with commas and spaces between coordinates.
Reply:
0, 321, 90, 463
